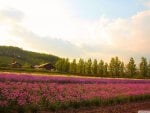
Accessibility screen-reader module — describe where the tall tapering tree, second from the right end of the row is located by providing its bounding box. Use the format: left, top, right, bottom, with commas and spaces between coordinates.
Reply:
127, 57, 136, 77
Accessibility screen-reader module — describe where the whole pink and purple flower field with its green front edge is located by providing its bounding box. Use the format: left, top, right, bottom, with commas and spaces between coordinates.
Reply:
0, 73, 150, 112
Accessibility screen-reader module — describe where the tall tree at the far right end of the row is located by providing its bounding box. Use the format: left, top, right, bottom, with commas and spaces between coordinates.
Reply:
140, 57, 148, 77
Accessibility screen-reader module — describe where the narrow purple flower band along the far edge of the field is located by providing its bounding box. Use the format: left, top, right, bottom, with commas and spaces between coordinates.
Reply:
0, 73, 150, 84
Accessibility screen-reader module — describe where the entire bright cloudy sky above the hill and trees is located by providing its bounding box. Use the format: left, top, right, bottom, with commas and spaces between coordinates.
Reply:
0, 0, 150, 60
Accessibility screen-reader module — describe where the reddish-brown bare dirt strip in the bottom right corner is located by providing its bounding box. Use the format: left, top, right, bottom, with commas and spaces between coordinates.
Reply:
42, 101, 150, 113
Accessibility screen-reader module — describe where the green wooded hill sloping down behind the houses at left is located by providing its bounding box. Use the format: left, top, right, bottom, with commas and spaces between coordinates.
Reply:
0, 46, 59, 67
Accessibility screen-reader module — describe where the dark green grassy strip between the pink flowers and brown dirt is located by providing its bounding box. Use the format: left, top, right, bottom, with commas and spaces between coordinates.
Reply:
0, 95, 150, 113
